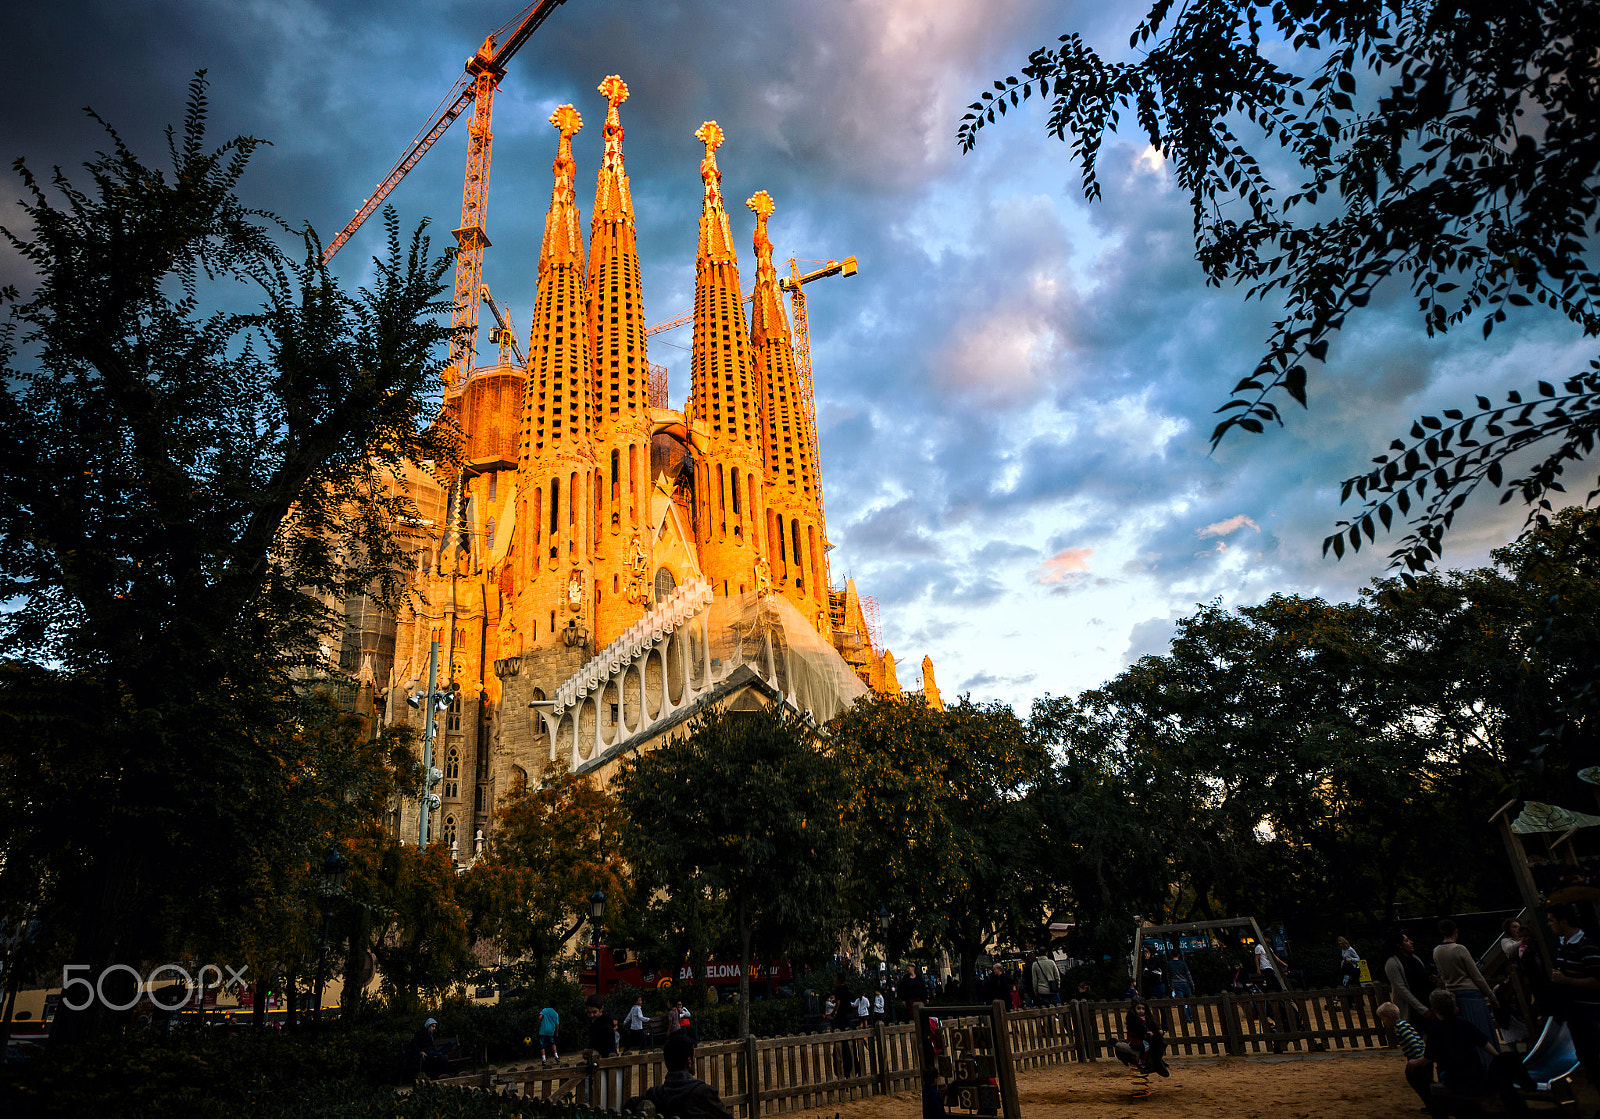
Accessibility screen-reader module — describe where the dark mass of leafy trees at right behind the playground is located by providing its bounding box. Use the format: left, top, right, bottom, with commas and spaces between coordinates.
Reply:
1029, 509, 1600, 953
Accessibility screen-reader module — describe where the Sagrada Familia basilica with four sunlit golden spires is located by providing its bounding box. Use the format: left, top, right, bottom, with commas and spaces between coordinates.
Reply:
341, 77, 939, 861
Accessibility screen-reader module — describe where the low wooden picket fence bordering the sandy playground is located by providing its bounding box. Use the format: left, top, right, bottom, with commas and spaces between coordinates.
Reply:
445, 986, 1392, 1119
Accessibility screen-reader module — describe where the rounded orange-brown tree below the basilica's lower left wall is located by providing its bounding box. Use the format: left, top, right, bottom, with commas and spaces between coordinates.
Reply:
462, 773, 632, 973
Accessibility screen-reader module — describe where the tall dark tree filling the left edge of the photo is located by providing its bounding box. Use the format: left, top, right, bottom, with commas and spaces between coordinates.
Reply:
0, 77, 454, 1039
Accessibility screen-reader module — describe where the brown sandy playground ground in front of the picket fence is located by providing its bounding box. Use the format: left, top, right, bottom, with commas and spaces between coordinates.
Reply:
818, 1050, 1421, 1119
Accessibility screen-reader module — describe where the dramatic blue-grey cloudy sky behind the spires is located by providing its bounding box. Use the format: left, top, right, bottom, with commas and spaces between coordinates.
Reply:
0, 0, 1582, 708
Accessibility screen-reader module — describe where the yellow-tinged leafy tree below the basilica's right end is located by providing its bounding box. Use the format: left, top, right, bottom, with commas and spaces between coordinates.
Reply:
829, 695, 1051, 994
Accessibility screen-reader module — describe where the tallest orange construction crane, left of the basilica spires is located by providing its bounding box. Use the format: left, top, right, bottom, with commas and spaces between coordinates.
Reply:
322, 0, 566, 391
